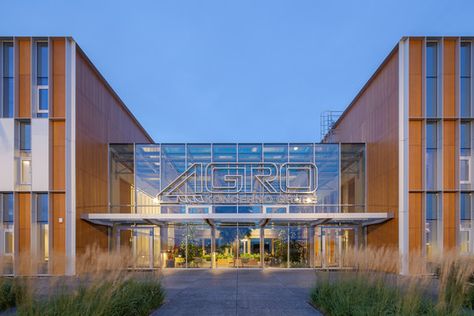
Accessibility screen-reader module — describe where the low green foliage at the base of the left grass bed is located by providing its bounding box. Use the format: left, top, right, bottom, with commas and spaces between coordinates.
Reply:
18, 280, 164, 316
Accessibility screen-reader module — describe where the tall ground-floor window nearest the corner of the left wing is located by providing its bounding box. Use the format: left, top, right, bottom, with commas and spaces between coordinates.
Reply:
36, 193, 49, 274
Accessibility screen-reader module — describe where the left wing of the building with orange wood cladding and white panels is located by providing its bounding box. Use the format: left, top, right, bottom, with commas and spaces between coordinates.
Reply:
0, 37, 152, 275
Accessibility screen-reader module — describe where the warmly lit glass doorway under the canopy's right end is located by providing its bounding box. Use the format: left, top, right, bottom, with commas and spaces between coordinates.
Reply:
321, 227, 357, 269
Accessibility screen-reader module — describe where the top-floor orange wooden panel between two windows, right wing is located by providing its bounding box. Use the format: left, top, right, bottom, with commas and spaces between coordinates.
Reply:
442, 38, 458, 118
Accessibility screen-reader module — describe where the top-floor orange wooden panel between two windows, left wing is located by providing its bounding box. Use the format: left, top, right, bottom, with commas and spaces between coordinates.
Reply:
16, 38, 31, 118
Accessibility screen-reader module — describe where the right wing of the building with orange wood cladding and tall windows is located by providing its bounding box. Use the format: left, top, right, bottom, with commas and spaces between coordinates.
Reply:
324, 37, 474, 273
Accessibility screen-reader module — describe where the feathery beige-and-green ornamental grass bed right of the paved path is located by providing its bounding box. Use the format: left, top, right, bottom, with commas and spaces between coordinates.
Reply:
310, 248, 474, 315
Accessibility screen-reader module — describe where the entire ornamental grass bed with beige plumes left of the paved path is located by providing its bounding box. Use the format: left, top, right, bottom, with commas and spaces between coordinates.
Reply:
0, 246, 165, 316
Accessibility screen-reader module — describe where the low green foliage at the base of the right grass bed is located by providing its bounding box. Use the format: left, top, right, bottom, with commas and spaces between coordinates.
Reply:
310, 278, 436, 315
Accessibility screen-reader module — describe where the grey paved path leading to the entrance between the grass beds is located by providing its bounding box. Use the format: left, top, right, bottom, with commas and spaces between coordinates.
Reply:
153, 269, 320, 316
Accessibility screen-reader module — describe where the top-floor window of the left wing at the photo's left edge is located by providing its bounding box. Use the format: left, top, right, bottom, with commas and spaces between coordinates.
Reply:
0, 42, 14, 117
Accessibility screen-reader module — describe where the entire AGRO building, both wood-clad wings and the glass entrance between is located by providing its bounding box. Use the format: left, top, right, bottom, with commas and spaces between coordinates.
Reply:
0, 37, 474, 275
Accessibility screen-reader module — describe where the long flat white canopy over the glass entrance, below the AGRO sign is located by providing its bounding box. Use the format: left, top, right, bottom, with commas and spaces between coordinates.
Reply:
81, 212, 393, 226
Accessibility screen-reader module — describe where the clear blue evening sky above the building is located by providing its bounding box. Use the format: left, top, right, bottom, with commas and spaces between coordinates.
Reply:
0, 0, 474, 142
